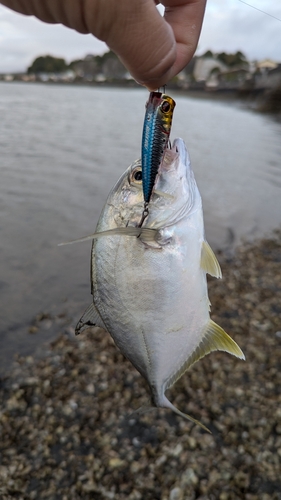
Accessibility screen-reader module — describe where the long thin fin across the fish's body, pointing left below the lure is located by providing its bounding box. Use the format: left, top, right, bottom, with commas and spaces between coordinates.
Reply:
58, 226, 158, 246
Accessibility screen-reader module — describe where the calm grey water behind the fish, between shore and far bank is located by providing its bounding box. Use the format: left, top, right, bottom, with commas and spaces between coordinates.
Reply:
0, 83, 281, 372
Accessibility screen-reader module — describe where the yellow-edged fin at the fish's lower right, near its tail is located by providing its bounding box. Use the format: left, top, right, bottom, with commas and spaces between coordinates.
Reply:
166, 319, 245, 389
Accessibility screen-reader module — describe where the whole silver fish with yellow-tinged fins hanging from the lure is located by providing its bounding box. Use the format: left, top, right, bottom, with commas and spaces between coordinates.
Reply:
76, 138, 245, 431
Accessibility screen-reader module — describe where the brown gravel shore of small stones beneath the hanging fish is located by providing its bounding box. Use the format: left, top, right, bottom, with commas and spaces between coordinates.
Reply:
0, 233, 281, 500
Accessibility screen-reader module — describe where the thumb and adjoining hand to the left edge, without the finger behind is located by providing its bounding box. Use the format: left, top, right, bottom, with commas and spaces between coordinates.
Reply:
0, 0, 176, 88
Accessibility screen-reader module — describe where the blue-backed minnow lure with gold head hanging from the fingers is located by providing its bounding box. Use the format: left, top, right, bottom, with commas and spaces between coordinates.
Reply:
141, 92, 176, 203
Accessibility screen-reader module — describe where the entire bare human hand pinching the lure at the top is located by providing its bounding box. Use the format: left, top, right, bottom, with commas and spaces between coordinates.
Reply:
0, 0, 206, 90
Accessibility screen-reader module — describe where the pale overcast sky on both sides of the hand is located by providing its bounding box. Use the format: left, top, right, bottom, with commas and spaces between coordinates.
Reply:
0, 0, 281, 73
